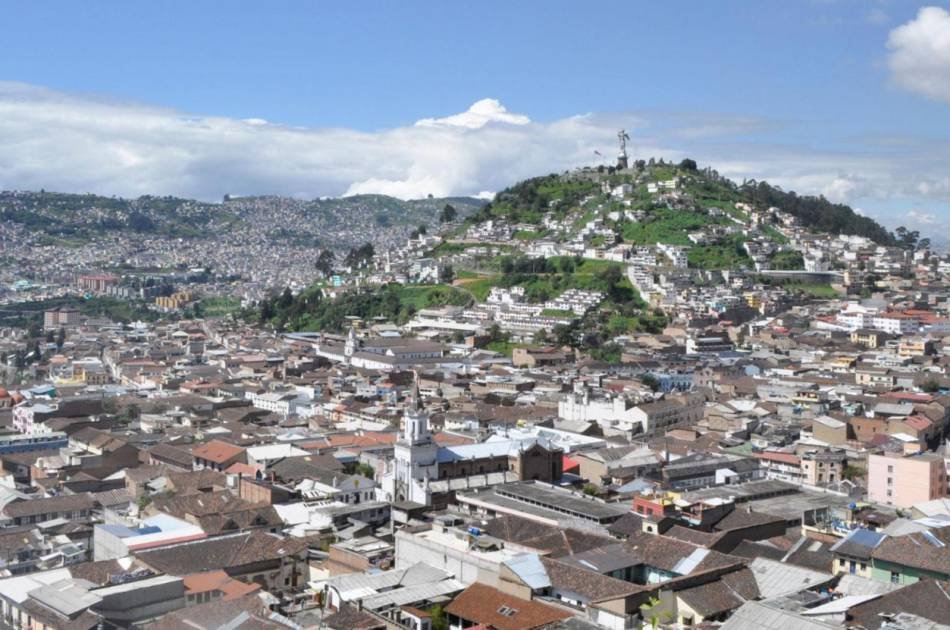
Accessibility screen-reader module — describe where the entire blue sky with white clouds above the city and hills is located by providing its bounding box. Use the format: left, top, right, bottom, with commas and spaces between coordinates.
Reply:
0, 0, 950, 239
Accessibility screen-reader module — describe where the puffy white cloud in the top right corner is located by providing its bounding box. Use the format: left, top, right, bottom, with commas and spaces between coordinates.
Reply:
887, 7, 950, 101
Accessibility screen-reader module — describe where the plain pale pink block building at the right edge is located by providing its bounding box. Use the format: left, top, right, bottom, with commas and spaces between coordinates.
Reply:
868, 452, 948, 508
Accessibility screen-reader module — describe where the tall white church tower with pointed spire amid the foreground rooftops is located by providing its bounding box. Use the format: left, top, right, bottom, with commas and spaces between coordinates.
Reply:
380, 380, 439, 505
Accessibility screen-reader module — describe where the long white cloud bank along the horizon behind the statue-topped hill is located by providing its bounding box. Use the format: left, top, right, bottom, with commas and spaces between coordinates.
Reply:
0, 83, 950, 228
